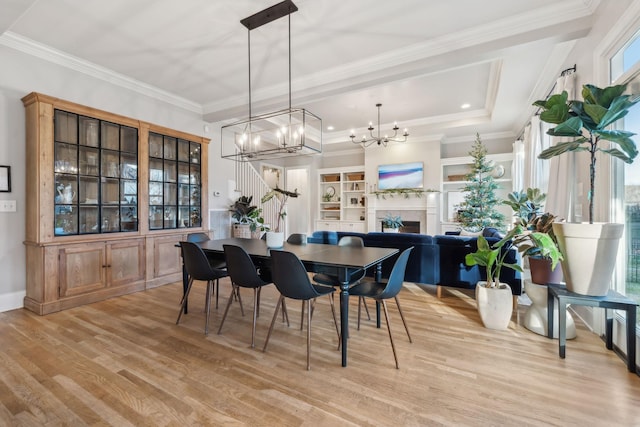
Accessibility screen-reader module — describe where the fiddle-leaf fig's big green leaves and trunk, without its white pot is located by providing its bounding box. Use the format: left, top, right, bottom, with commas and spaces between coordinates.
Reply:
533, 84, 640, 224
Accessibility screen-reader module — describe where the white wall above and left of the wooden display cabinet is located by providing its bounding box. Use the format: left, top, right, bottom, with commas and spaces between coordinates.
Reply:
0, 45, 207, 311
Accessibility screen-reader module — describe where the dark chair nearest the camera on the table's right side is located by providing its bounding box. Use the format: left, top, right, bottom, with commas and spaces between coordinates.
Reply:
349, 247, 413, 369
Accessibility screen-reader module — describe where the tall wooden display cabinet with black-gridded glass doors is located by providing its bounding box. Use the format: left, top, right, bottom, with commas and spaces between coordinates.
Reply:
22, 93, 209, 314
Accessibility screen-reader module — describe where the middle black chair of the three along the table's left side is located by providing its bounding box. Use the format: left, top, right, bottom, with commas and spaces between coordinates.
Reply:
218, 245, 286, 347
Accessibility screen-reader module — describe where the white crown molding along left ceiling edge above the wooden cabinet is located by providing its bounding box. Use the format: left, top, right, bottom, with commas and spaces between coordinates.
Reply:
0, 31, 202, 115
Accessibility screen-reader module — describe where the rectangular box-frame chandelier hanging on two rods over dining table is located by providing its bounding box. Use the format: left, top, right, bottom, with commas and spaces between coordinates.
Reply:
221, 0, 322, 162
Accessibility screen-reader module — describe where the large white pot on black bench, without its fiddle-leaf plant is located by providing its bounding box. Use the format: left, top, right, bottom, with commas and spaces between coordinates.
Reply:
553, 222, 624, 296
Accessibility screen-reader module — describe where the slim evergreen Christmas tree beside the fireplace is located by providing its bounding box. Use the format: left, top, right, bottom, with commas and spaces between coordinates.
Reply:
459, 134, 505, 231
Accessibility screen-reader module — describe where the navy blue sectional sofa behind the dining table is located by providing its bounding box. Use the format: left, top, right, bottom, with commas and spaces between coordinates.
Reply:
307, 229, 522, 297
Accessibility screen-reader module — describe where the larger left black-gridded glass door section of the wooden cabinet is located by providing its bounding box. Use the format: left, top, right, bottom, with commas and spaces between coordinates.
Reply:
54, 110, 138, 236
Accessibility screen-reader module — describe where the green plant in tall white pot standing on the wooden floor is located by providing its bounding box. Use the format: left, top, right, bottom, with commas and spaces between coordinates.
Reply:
465, 234, 522, 330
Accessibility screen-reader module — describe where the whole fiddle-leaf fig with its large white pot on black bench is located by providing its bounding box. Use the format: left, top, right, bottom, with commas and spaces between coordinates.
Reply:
534, 84, 640, 295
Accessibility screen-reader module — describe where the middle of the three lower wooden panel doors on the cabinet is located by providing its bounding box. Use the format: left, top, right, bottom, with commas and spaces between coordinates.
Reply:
107, 239, 145, 286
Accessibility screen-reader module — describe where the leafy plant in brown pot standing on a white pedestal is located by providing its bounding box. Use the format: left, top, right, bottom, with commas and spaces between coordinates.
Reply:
503, 188, 563, 285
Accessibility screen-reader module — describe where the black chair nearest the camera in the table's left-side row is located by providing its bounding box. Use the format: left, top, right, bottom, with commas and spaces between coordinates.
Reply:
262, 250, 340, 370
